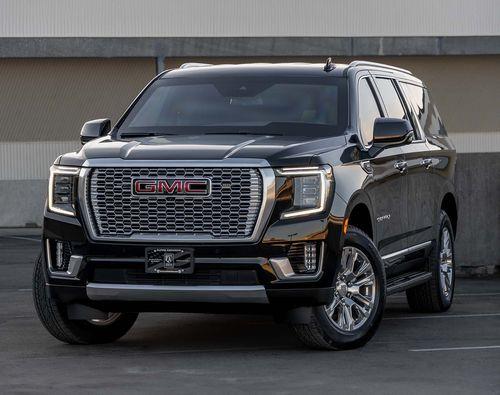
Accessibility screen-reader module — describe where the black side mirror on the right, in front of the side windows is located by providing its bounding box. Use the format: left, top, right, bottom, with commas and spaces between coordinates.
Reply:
373, 118, 413, 148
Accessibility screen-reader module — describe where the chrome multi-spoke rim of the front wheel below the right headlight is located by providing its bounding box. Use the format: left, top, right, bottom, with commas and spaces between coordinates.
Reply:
324, 247, 377, 332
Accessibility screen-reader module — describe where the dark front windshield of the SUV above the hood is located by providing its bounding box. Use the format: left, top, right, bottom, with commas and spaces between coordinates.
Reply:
119, 76, 347, 137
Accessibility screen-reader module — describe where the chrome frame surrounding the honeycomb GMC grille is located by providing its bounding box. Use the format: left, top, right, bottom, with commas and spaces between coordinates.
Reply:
78, 158, 275, 243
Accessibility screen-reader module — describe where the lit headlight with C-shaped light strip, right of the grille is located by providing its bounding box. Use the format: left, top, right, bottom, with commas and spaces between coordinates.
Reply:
279, 166, 333, 218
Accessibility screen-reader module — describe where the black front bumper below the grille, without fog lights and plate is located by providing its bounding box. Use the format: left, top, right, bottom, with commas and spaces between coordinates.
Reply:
43, 183, 342, 312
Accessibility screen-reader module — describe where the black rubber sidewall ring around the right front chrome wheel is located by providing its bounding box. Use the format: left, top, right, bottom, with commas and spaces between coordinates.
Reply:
314, 227, 386, 348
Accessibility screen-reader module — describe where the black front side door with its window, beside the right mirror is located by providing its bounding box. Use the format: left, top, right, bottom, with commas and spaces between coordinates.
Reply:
358, 77, 407, 262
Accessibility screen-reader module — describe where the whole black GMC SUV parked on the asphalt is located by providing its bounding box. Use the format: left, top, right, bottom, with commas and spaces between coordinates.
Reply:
33, 59, 457, 349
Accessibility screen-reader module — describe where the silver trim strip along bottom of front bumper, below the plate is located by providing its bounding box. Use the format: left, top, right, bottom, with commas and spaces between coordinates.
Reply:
87, 283, 269, 304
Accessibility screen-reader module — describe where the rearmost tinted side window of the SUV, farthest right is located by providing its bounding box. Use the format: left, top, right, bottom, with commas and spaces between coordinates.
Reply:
401, 82, 446, 136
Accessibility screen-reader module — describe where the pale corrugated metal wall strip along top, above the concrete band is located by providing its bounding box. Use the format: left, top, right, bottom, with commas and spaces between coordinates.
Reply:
0, 0, 500, 37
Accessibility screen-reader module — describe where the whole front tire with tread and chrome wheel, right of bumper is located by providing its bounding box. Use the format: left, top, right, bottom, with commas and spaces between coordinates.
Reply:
292, 226, 386, 350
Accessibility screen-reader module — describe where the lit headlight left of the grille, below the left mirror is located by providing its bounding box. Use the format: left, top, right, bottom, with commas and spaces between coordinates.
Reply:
48, 166, 80, 217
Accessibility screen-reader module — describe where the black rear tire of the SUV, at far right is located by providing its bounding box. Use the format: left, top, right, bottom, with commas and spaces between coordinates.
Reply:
406, 210, 455, 313
